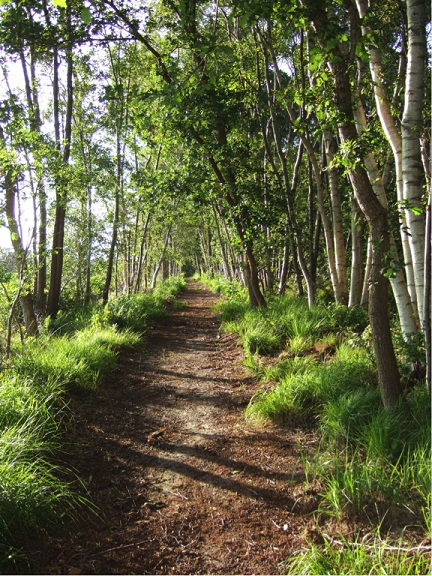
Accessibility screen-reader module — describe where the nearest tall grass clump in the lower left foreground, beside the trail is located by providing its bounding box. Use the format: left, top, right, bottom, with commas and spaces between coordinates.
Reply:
0, 373, 85, 573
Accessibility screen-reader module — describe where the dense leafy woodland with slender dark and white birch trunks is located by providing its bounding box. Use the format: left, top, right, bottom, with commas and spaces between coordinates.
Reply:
0, 0, 431, 568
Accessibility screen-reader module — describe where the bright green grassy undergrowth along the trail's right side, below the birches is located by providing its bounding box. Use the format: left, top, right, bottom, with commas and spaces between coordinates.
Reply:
209, 280, 431, 574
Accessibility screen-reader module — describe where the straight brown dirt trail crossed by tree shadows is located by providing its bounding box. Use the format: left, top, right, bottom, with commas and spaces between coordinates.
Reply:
24, 283, 317, 574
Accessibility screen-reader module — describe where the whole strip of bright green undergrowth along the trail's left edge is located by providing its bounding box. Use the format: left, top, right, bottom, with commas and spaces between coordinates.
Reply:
0, 278, 185, 573
